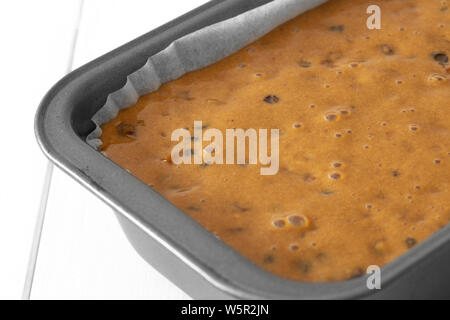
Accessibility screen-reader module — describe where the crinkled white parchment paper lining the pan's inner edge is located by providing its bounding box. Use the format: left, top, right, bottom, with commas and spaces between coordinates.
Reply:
86, 0, 327, 149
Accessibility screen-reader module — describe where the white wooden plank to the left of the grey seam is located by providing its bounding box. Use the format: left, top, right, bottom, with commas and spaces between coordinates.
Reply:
0, 0, 83, 299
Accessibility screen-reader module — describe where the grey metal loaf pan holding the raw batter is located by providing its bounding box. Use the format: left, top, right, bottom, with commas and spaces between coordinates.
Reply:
35, 0, 450, 299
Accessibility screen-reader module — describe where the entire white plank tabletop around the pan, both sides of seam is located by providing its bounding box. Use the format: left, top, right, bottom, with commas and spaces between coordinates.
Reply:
0, 0, 207, 299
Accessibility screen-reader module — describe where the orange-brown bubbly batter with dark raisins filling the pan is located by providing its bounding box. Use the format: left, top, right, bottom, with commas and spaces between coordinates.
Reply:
101, 0, 450, 282
